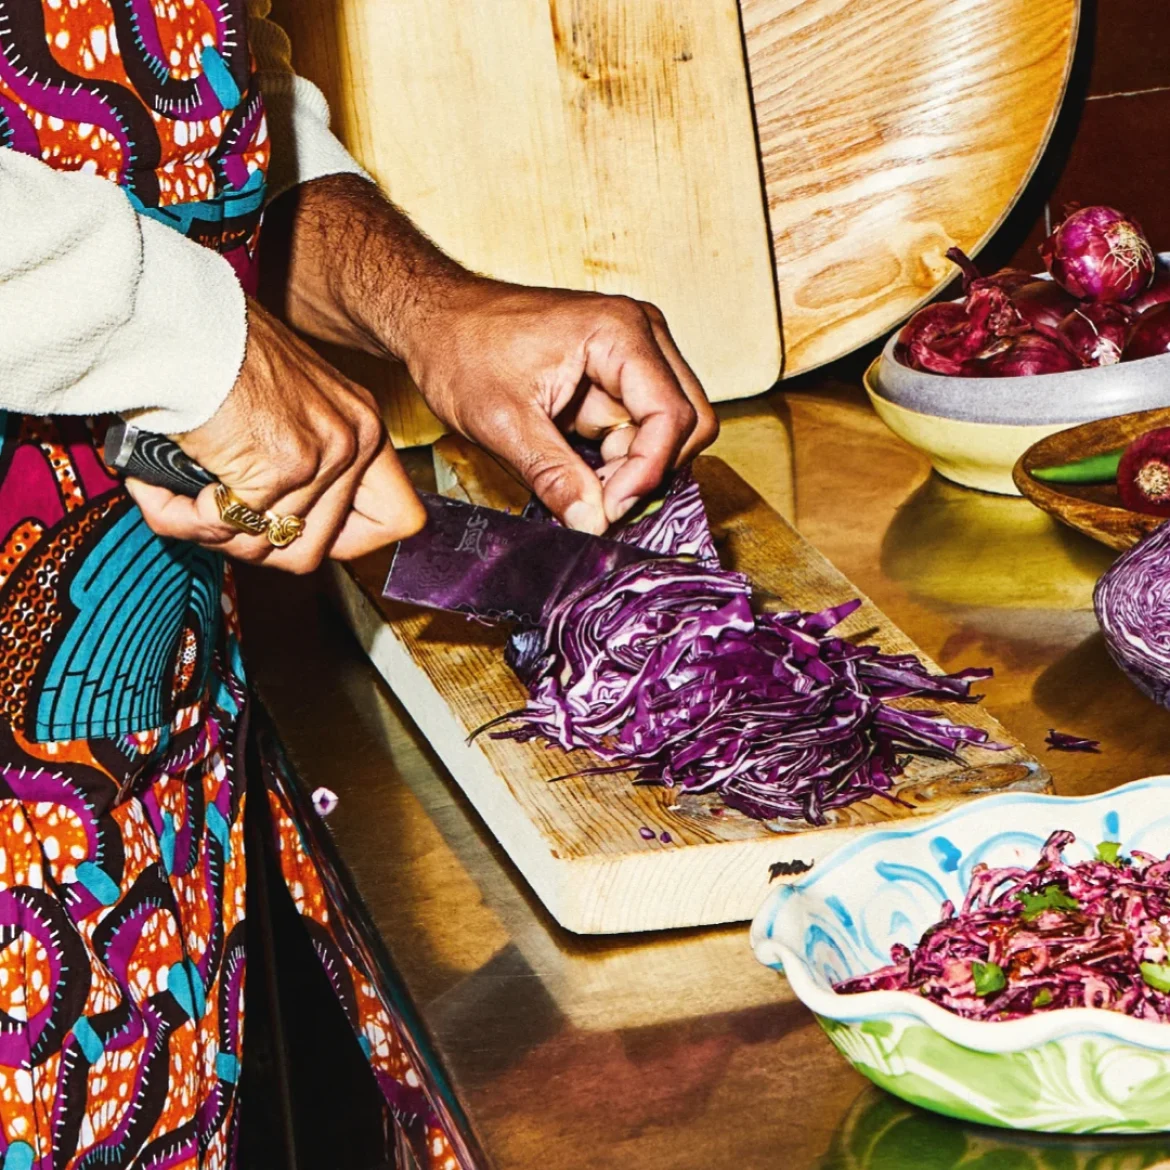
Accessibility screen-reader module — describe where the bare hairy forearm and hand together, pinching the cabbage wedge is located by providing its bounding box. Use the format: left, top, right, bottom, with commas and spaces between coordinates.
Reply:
264, 174, 718, 532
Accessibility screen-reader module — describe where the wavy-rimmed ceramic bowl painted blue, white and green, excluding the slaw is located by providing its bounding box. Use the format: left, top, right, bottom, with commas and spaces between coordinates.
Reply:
751, 776, 1170, 1134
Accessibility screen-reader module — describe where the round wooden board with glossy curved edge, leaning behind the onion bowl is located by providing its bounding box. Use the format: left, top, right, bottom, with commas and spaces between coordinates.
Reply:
741, 0, 1080, 377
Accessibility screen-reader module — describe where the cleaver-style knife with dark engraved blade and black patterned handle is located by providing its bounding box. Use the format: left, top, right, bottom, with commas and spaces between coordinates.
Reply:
103, 419, 658, 626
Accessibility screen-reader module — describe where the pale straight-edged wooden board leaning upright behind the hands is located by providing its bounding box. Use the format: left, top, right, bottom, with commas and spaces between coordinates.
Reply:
265, 0, 782, 438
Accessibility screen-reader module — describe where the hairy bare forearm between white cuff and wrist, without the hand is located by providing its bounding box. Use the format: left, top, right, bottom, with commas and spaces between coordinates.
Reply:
263, 174, 476, 364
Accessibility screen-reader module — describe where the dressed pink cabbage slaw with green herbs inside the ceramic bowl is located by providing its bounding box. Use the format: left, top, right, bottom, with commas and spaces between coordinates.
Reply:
835, 830, 1170, 1023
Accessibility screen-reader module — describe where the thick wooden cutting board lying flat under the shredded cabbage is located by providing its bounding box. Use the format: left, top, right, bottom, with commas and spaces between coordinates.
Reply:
337, 440, 1048, 934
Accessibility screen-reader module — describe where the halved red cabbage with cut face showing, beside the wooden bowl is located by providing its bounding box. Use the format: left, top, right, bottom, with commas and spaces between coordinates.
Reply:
1093, 524, 1170, 707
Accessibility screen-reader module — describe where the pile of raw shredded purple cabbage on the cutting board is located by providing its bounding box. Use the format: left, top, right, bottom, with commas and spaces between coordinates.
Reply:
494, 463, 998, 824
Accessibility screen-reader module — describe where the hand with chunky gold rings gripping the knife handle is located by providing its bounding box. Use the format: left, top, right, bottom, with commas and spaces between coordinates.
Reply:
126, 301, 426, 573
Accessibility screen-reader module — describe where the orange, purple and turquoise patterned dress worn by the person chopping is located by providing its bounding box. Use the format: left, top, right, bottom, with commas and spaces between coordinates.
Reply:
0, 0, 459, 1170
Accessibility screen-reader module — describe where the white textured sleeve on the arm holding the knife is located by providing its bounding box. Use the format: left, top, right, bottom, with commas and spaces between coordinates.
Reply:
0, 149, 247, 434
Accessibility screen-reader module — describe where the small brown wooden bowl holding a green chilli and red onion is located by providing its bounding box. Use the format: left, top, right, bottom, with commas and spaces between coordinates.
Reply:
1012, 407, 1170, 549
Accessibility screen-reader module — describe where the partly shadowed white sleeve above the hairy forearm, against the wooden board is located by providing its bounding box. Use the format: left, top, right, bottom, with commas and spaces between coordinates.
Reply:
248, 0, 372, 200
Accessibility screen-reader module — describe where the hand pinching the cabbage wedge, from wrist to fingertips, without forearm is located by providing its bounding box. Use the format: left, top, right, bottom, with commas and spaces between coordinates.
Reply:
405, 277, 718, 534
